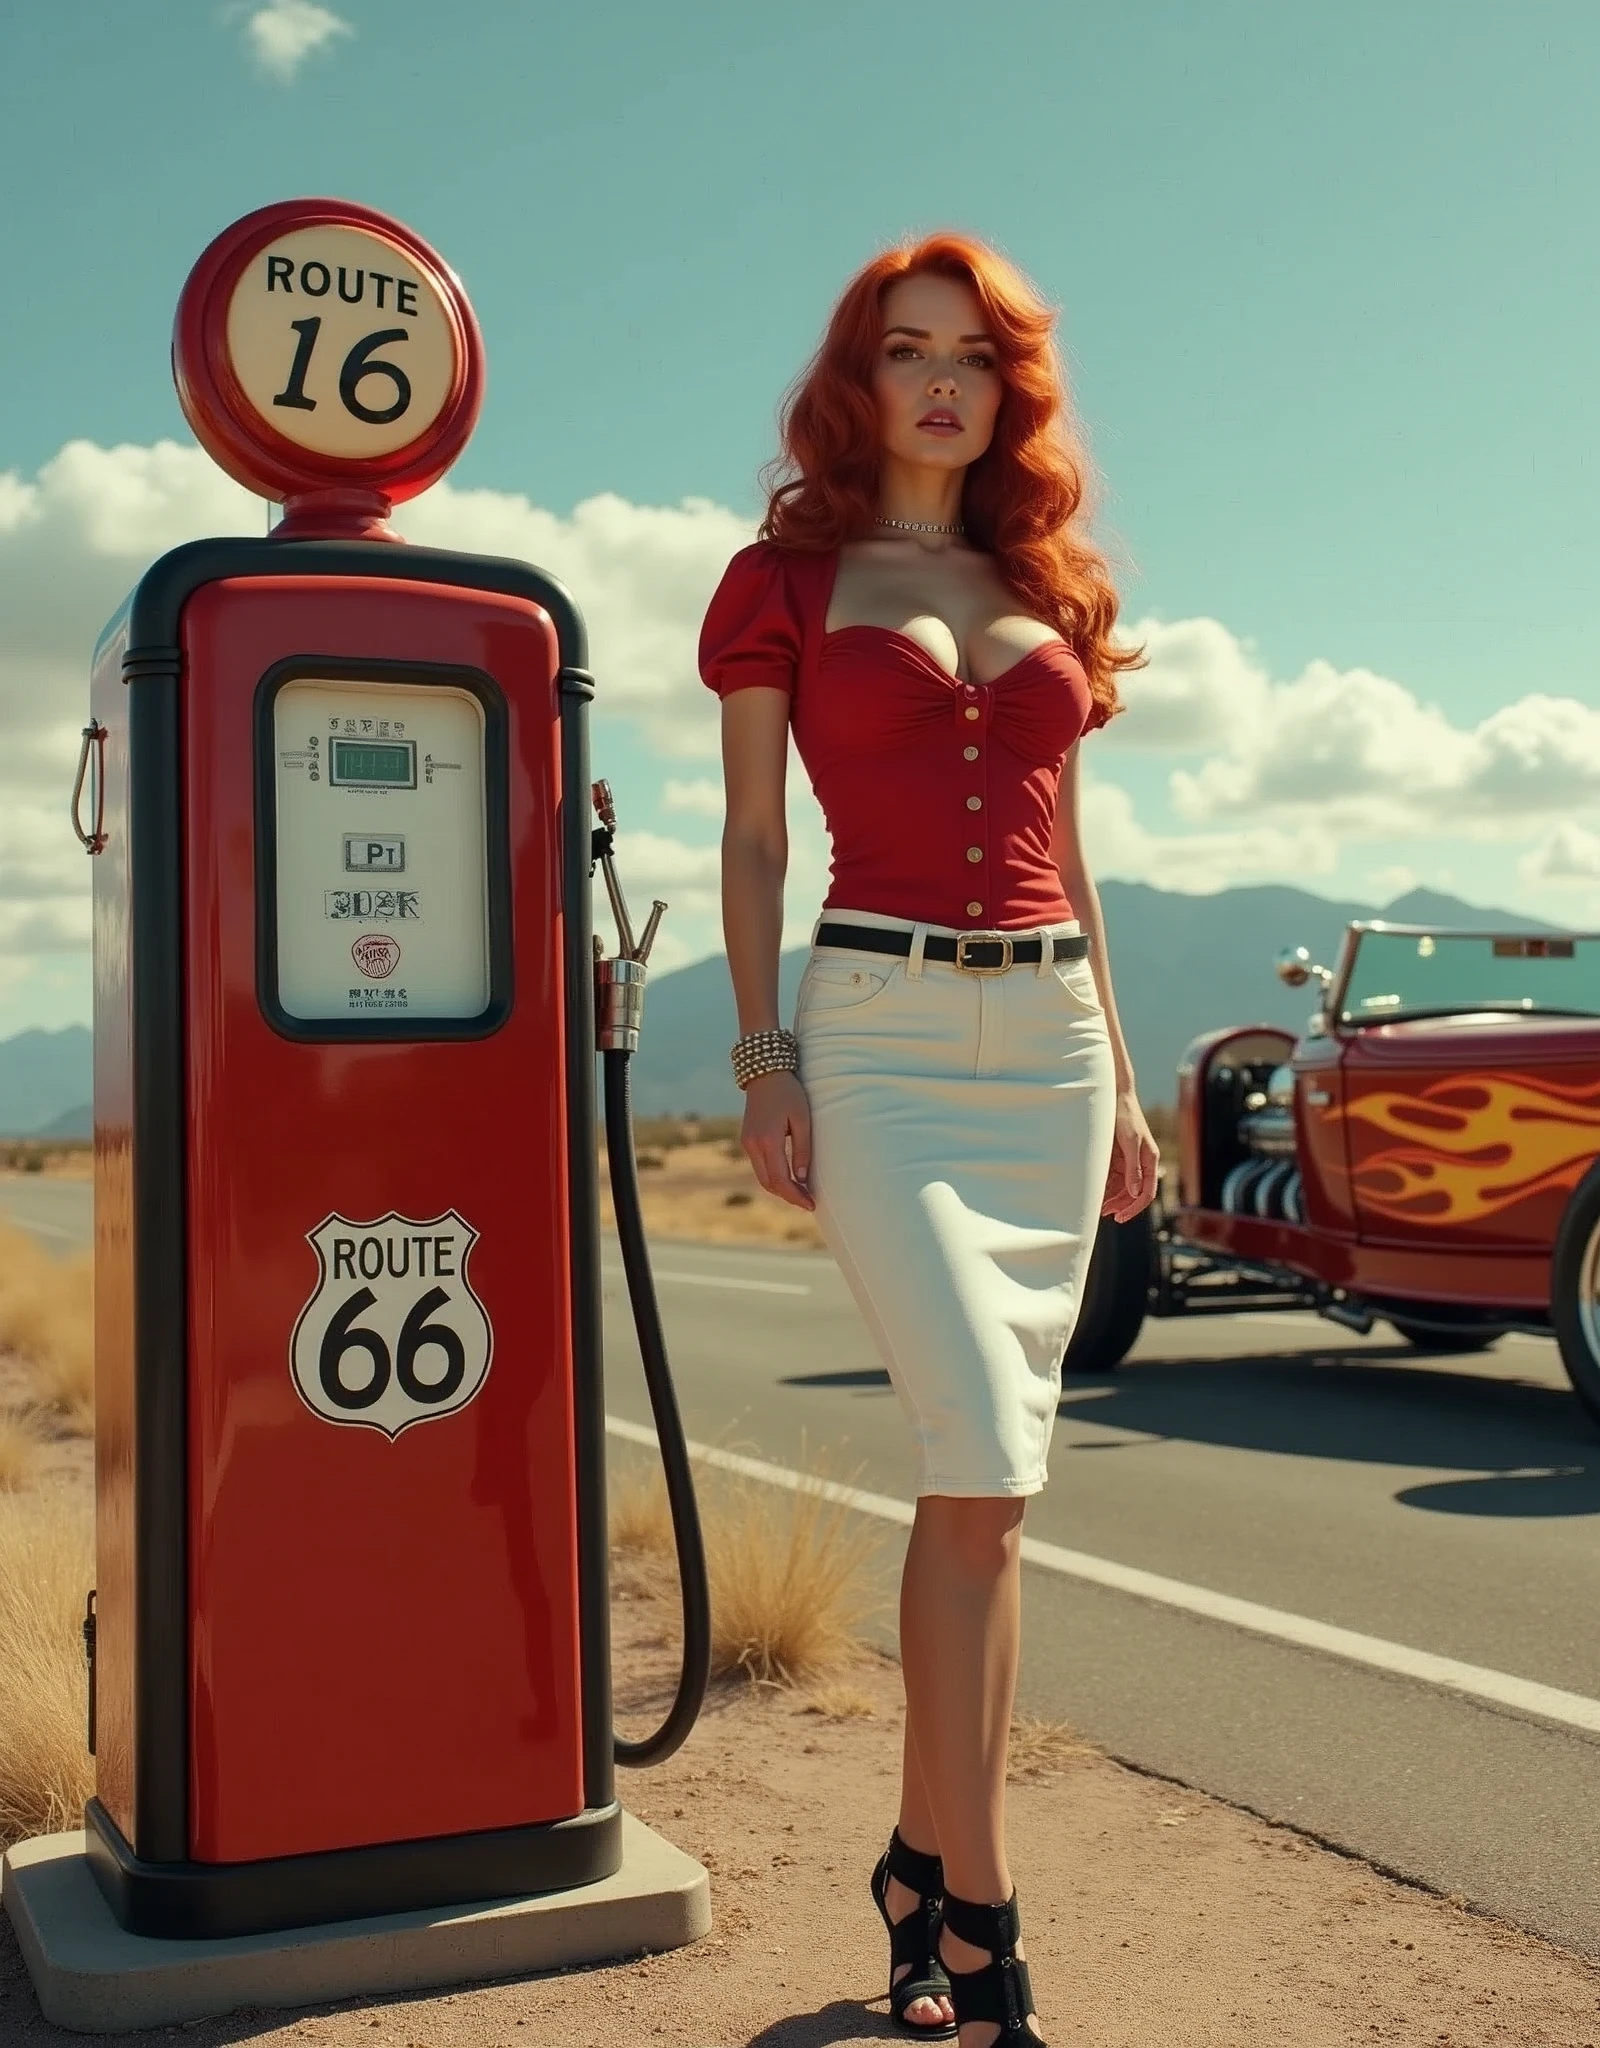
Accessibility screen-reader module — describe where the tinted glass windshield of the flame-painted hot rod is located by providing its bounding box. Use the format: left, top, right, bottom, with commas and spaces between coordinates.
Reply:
1340, 932, 1600, 1024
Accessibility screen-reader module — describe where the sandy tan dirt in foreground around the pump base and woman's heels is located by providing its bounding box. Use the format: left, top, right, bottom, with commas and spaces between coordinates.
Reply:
0, 1599, 1600, 2048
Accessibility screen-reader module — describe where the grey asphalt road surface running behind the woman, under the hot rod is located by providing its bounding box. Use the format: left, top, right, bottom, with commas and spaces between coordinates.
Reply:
0, 1180, 1600, 1960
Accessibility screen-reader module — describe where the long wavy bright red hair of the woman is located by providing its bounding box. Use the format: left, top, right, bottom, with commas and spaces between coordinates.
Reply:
760, 233, 1145, 711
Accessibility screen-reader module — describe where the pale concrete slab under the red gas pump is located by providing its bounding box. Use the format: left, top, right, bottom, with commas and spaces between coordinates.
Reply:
0, 1812, 711, 2034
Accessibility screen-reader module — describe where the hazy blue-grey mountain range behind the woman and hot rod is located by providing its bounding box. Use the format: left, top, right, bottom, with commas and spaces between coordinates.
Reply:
633, 881, 1549, 1116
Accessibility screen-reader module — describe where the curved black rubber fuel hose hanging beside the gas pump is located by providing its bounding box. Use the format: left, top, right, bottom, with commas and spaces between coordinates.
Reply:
600, 1053, 711, 1763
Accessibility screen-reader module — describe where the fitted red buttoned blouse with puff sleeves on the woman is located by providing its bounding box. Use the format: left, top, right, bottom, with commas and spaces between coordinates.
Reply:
701, 541, 1104, 932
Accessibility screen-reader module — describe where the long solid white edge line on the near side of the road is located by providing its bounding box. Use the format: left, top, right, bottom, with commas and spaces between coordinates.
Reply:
606, 1415, 1600, 1735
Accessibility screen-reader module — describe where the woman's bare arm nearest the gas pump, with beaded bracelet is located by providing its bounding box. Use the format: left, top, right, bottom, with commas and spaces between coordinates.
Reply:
723, 686, 815, 1208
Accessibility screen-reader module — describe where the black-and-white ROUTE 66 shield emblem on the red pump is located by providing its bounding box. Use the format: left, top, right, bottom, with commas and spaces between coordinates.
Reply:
289, 1208, 494, 1438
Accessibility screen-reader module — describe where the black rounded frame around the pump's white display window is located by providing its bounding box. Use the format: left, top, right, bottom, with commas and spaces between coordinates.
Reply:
254, 653, 512, 1044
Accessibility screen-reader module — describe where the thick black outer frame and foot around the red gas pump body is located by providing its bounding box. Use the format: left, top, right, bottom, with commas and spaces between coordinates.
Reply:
84, 539, 621, 1935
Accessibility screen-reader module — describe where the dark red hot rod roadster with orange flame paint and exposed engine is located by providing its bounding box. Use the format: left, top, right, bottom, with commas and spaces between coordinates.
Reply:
1065, 922, 1600, 1421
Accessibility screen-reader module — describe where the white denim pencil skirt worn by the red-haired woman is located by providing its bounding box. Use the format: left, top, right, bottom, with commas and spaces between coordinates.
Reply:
795, 909, 1114, 1495
